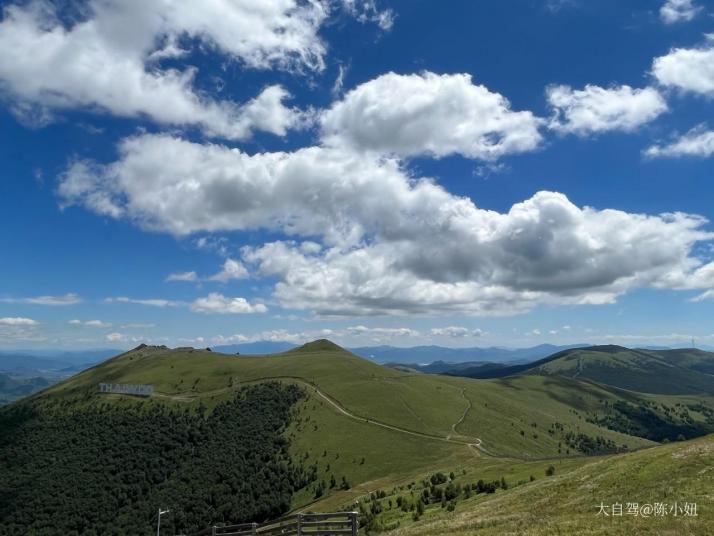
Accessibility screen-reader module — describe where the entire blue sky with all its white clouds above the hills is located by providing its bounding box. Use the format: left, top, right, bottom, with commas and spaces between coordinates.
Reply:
0, 0, 714, 349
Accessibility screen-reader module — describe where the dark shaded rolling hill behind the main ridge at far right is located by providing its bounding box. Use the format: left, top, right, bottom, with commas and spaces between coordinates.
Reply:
449, 345, 714, 395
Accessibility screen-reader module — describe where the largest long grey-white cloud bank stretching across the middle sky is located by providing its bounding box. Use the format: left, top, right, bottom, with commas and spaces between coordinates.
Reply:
60, 135, 714, 315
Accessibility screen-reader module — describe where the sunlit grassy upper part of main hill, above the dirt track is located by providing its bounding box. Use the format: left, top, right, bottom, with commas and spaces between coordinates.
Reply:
37, 342, 660, 457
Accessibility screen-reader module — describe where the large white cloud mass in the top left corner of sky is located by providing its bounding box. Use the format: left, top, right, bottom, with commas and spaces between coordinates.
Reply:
0, 0, 314, 139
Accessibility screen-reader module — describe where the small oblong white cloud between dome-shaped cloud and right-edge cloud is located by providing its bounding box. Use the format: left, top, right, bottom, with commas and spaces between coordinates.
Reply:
546, 85, 667, 136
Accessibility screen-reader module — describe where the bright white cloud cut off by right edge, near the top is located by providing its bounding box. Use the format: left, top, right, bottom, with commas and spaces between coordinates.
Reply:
652, 34, 714, 96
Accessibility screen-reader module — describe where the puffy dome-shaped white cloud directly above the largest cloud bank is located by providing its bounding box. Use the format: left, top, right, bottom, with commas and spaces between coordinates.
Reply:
320, 72, 542, 160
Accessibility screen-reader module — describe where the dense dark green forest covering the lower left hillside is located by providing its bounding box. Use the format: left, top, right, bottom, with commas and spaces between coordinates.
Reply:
0, 382, 314, 536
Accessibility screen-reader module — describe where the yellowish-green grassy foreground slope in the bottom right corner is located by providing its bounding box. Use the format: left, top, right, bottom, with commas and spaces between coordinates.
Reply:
390, 436, 714, 536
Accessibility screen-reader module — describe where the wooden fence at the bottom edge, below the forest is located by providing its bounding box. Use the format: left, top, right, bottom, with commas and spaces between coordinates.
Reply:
195, 512, 358, 536
